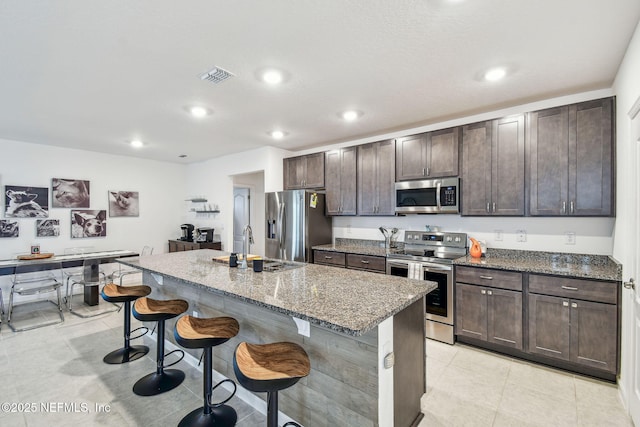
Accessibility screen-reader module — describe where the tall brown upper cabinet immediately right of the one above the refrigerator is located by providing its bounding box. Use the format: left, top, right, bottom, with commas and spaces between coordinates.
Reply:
325, 147, 357, 215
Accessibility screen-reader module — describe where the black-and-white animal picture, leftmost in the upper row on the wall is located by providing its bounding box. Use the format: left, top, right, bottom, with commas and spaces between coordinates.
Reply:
4, 185, 49, 218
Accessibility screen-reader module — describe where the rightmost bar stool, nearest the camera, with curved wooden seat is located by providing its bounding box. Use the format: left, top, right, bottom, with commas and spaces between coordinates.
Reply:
233, 342, 311, 427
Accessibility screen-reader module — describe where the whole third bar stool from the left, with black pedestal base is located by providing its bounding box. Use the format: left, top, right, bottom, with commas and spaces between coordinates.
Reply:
174, 315, 240, 427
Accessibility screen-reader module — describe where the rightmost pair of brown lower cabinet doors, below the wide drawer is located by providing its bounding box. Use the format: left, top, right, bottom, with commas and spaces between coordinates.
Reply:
529, 294, 618, 373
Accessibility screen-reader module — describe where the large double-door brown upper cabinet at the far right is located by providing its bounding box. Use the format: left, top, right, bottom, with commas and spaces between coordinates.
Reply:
527, 98, 615, 216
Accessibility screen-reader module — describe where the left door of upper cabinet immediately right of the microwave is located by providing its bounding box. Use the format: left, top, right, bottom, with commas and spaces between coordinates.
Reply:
462, 122, 491, 215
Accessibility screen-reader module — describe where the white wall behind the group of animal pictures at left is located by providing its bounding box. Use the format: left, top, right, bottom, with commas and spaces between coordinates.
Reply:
0, 139, 186, 298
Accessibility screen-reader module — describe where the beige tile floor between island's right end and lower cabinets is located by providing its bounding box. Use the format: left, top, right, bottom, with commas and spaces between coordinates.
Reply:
420, 340, 633, 427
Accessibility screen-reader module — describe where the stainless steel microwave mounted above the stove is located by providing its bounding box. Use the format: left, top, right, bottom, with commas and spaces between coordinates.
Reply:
396, 177, 460, 215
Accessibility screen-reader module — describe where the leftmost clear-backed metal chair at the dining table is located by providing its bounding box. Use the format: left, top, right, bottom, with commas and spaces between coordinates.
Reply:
7, 261, 64, 332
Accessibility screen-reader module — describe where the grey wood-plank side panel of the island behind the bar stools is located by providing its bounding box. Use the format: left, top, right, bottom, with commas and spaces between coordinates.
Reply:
143, 273, 379, 427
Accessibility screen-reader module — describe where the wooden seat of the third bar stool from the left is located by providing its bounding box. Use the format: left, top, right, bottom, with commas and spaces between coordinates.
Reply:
174, 315, 240, 348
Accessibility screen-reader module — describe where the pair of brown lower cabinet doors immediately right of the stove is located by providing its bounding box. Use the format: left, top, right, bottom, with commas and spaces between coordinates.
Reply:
456, 283, 522, 350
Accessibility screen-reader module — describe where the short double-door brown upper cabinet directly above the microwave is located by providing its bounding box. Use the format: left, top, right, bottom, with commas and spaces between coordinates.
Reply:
396, 127, 460, 181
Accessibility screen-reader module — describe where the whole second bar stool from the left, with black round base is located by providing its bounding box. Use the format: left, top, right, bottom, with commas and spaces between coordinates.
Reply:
132, 297, 189, 396
